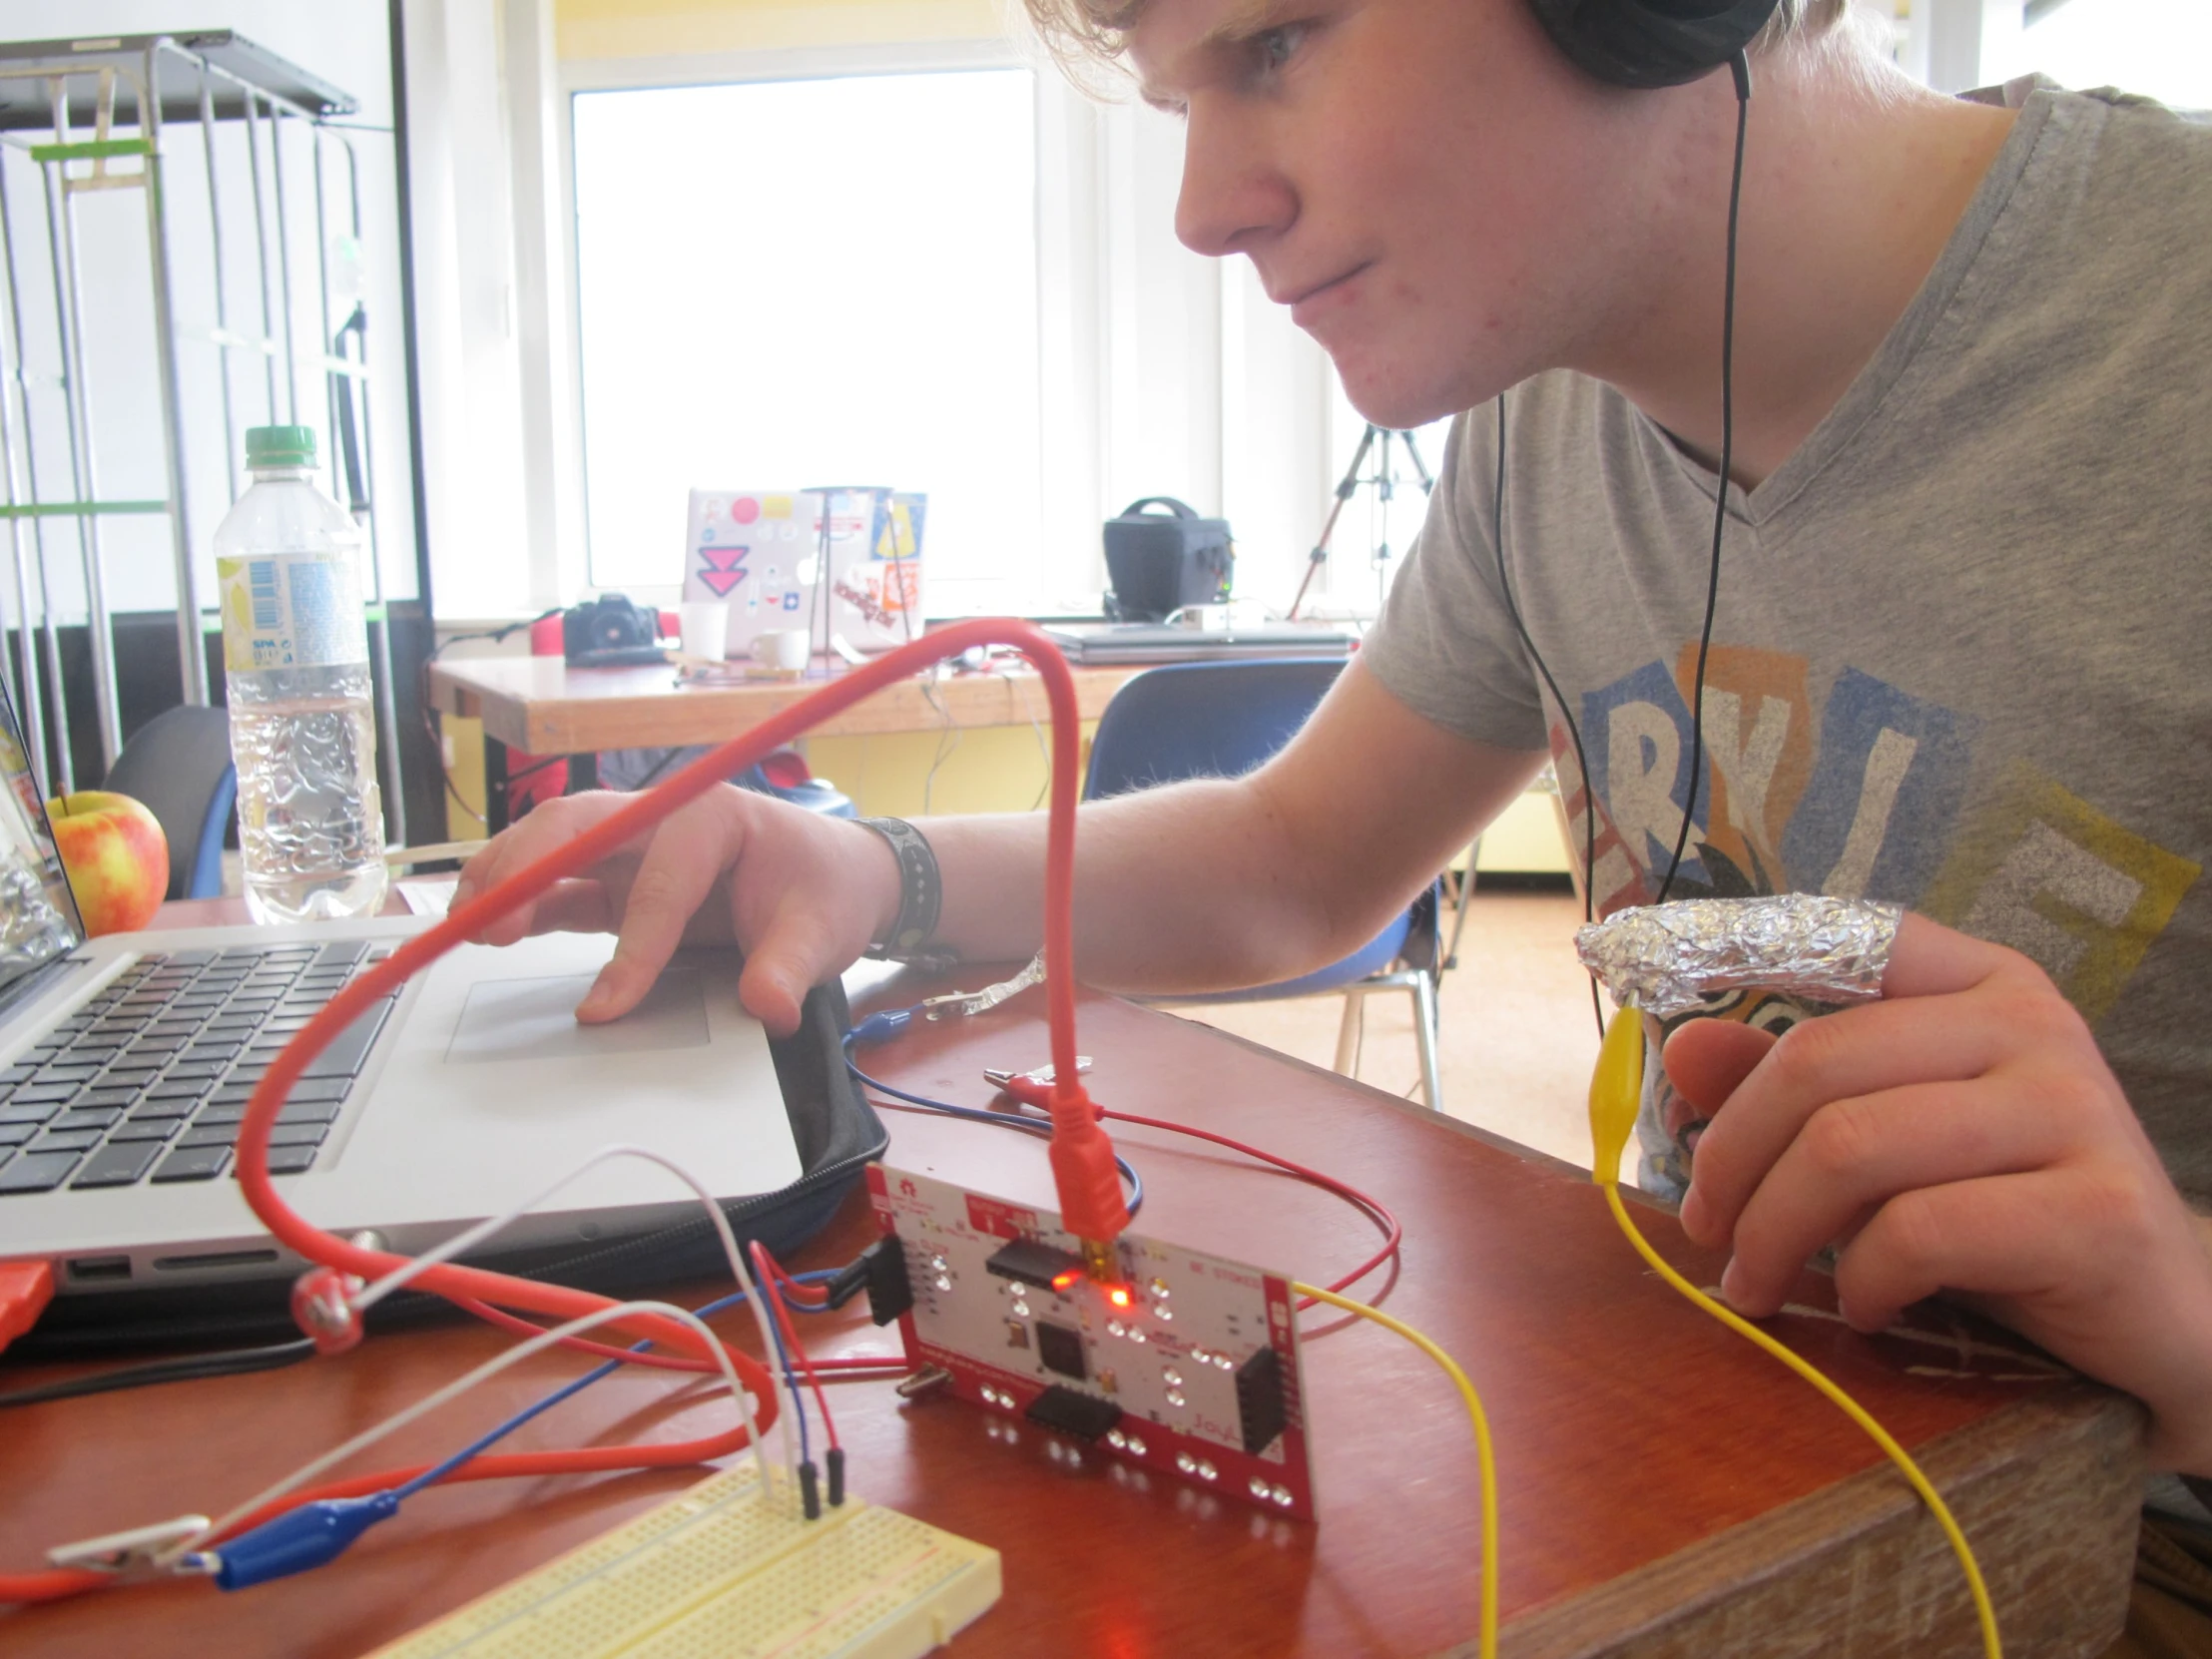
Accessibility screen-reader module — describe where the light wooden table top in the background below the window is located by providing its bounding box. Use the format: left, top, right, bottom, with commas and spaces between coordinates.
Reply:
429, 657, 1144, 755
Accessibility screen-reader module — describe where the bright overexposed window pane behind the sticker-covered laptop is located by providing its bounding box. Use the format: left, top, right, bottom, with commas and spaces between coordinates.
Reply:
573, 69, 1042, 611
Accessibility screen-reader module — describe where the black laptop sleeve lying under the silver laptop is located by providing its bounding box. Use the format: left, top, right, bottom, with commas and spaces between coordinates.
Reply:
7, 980, 891, 1361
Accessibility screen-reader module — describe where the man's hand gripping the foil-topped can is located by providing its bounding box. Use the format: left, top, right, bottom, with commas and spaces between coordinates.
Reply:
1666, 915, 2212, 1473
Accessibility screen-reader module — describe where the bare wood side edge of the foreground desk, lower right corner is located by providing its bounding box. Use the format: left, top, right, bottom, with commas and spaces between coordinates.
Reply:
1486, 1382, 2143, 1659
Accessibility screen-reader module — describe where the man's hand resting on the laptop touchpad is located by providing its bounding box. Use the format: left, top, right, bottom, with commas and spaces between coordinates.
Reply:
453, 783, 898, 1035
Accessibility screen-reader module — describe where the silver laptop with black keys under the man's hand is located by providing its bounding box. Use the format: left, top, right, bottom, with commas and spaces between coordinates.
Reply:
0, 693, 801, 1294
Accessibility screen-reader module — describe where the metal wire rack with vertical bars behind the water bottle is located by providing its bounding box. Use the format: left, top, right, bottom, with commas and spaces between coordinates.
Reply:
0, 29, 407, 842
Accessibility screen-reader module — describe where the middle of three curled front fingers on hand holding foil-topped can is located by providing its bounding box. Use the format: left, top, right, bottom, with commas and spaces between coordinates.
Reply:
1721, 1079, 2077, 1319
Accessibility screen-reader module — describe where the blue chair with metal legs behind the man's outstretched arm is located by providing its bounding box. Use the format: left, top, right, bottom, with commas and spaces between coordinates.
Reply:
1084, 657, 1442, 1110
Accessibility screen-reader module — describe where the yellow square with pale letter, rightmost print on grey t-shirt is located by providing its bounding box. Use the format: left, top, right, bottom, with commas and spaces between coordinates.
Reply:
1918, 764, 2203, 1026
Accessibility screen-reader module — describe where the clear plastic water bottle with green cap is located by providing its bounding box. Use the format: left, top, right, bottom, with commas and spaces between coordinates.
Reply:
215, 427, 387, 922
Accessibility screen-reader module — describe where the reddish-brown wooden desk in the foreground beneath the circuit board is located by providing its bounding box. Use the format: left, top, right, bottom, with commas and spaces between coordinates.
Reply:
0, 959, 2141, 1659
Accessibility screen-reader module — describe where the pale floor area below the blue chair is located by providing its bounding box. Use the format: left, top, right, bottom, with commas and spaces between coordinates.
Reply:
1179, 891, 1627, 1168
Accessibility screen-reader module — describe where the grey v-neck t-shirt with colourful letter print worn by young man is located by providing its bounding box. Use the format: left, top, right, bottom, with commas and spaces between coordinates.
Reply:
1363, 82, 2212, 1208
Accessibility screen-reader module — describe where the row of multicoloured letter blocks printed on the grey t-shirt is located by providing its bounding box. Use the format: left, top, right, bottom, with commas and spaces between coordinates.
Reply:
1550, 642, 2203, 1195
